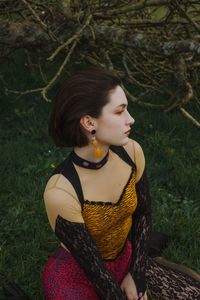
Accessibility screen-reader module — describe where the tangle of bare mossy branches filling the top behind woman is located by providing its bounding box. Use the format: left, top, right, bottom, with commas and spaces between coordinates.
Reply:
0, 0, 200, 125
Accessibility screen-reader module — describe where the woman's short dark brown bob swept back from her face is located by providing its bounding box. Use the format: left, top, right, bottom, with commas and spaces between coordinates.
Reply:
49, 67, 121, 147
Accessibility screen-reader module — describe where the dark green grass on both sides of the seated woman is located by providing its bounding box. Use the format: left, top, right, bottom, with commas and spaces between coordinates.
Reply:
0, 57, 200, 300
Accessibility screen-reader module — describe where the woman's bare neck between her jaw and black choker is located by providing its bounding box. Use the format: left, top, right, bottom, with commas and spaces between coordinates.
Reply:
74, 144, 109, 163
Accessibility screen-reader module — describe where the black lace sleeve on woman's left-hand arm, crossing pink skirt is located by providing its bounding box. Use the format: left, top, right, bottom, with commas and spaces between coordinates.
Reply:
55, 215, 127, 300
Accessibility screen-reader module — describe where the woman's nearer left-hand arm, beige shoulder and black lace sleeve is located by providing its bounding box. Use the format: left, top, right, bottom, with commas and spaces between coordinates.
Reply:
44, 176, 127, 300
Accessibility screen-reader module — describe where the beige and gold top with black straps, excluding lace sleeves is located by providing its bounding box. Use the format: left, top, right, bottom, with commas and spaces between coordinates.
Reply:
44, 140, 144, 260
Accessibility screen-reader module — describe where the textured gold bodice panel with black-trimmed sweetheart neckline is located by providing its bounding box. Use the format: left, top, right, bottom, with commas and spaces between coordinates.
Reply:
82, 170, 137, 260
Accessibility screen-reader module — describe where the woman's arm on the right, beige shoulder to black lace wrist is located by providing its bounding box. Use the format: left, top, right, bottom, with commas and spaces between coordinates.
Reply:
127, 140, 151, 295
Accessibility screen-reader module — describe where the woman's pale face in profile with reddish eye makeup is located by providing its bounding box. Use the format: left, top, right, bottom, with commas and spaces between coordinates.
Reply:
95, 86, 135, 146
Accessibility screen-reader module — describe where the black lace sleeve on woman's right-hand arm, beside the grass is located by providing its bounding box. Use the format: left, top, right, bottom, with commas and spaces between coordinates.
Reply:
130, 170, 151, 296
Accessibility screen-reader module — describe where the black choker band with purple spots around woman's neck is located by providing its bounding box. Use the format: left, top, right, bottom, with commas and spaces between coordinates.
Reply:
70, 151, 109, 170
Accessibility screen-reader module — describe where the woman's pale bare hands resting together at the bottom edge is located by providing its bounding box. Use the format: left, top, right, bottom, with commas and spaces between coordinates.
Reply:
120, 273, 148, 300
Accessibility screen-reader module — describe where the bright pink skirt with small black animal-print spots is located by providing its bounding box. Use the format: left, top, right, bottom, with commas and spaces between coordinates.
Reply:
43, 241, 132, 300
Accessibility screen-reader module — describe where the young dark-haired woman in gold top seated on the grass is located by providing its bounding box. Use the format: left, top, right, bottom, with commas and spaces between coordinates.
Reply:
43, 68, 200, 300
